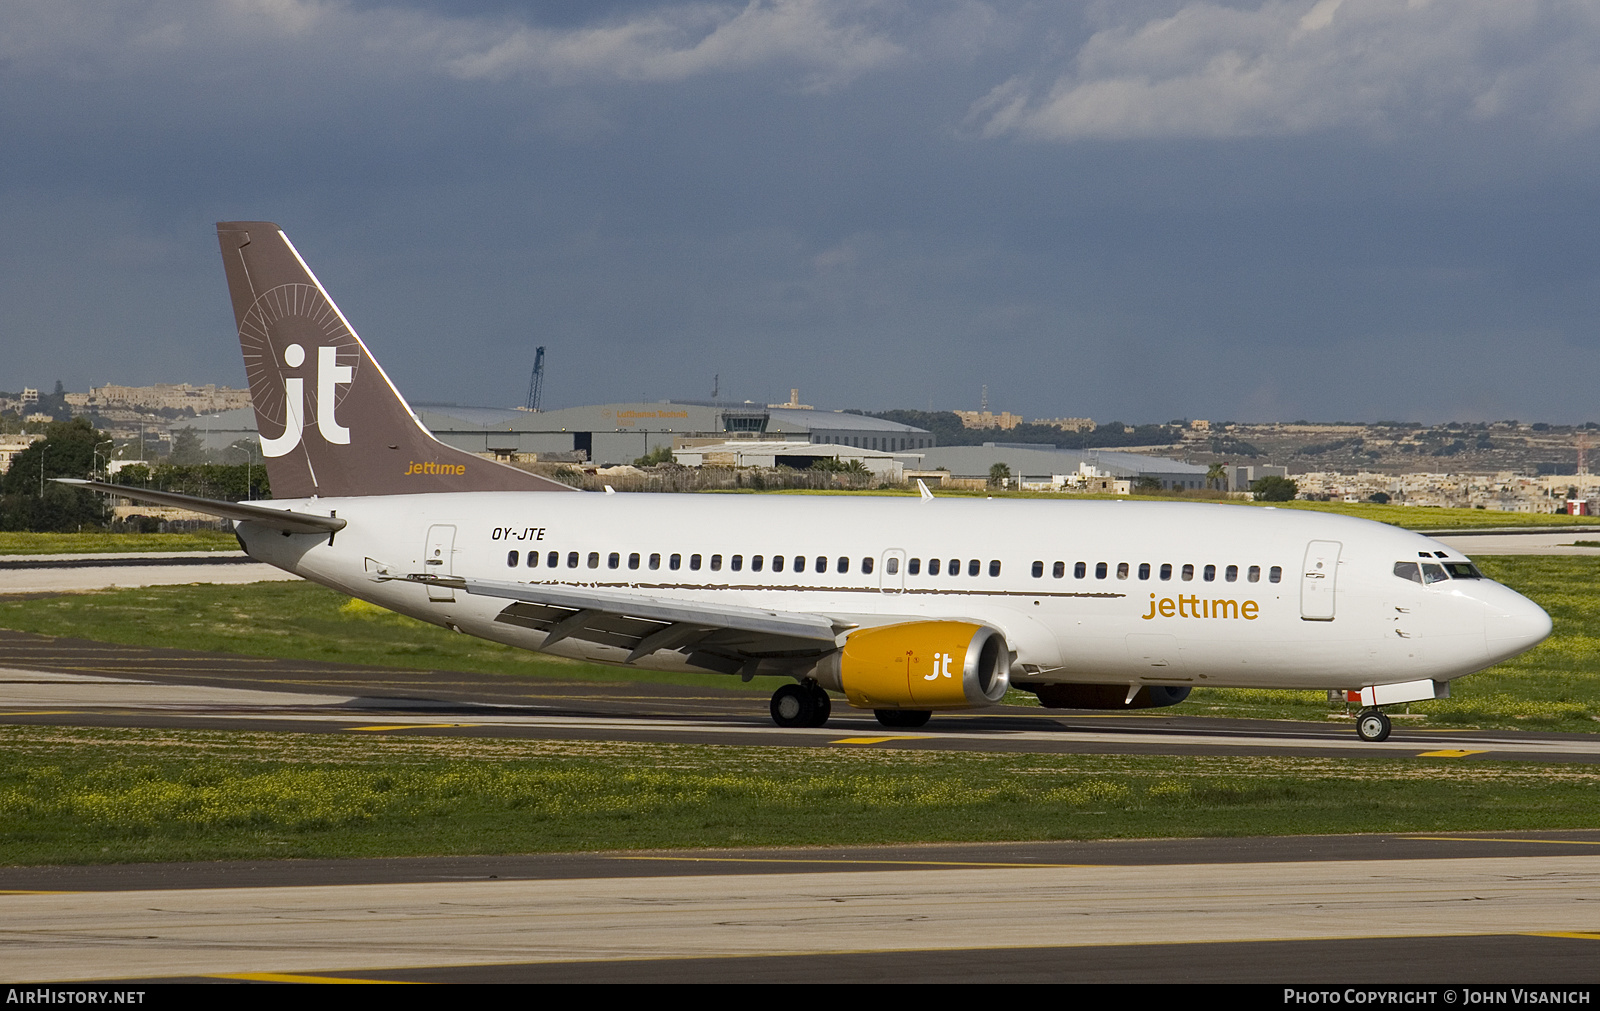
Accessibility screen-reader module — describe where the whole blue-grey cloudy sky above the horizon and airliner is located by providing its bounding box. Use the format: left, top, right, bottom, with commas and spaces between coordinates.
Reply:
0, 0, 1600, 422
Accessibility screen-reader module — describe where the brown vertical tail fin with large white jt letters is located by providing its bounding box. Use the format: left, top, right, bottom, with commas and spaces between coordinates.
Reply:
216, 221, 573, 499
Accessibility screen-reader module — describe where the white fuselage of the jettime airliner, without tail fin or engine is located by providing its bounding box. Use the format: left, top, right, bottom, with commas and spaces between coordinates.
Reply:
238, 493, 1550, 689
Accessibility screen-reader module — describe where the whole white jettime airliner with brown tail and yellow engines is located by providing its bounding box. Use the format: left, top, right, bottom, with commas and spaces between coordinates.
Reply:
62, 221, 1550, 741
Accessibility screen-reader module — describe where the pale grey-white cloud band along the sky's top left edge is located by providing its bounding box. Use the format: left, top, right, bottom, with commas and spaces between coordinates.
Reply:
0, 0, 902, 90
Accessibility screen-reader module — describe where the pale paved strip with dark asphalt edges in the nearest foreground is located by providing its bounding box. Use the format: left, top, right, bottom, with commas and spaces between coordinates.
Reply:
0, 832, 1600, 984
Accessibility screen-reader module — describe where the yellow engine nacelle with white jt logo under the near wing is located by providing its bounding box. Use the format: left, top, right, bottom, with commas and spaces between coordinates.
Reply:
813, 621, 1011, 709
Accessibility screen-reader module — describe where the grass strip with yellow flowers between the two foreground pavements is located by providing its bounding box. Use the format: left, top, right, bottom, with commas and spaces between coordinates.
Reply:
0, 726, 1600, 864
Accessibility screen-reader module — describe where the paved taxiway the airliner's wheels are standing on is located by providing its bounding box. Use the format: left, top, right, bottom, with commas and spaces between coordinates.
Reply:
0, 630, 1600, 763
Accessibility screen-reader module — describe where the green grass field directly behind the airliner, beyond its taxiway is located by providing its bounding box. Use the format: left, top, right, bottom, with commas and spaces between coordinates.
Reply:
0, 555, 1600, 733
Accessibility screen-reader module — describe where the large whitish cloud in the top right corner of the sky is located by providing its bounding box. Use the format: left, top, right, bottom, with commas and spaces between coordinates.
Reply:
968, 0, 1600, 141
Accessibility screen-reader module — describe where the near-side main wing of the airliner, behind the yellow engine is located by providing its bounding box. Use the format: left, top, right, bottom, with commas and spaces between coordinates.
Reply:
388, 569, 856, 677
